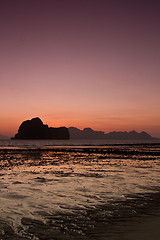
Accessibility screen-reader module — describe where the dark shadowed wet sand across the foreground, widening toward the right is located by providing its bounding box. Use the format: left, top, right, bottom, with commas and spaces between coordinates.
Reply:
0, 192, 160, 240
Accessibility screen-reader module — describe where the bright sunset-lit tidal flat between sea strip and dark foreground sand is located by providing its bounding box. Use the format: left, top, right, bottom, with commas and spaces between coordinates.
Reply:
0, 146, 160, 236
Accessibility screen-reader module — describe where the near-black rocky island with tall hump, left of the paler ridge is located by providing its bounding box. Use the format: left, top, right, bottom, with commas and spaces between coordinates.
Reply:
12, 117, 69, 140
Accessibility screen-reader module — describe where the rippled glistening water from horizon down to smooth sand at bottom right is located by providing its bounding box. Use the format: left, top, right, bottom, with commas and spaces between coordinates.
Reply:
0, 139, 160, 240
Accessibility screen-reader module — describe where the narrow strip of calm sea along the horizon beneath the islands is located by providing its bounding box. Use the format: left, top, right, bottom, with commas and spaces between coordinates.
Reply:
0, 139, 160, 150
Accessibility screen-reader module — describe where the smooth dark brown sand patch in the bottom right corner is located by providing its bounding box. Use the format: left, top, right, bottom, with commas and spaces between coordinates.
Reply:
90, 215, 160, 240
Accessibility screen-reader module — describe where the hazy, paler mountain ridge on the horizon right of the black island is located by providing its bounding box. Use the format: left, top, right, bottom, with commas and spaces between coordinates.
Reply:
68, 127, 155, 140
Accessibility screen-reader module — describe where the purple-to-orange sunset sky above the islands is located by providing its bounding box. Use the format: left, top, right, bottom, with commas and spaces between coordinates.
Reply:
0, 0, 160, 137
